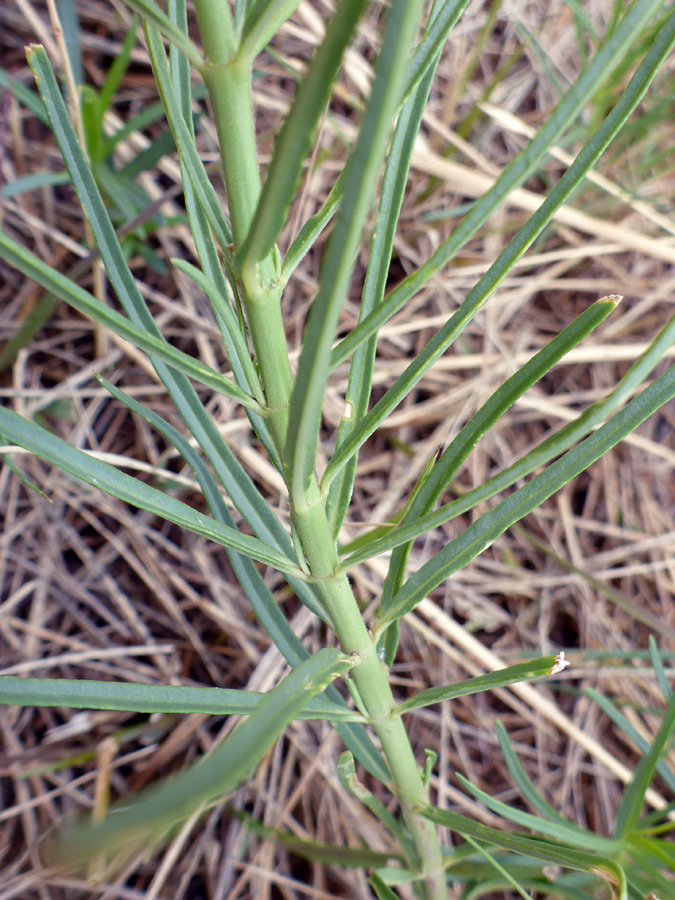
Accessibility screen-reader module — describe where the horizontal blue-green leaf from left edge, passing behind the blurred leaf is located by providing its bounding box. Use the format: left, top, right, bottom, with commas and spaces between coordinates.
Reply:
0, 675, 363, 722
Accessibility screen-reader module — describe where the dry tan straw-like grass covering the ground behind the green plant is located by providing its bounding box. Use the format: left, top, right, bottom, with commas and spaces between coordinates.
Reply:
0, 0, 675, 900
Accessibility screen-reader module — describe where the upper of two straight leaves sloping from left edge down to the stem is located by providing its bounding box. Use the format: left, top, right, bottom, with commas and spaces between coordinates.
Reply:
0, 232, 262, 411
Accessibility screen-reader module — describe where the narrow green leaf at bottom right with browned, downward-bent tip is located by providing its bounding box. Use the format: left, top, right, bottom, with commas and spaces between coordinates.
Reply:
421, 806, 628, 900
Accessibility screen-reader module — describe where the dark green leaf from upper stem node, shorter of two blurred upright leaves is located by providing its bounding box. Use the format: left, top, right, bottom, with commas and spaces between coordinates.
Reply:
236, 0, 367, 270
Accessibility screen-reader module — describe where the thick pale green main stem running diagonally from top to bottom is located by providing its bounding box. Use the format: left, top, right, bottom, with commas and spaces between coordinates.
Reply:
195, 0, 447, 900
